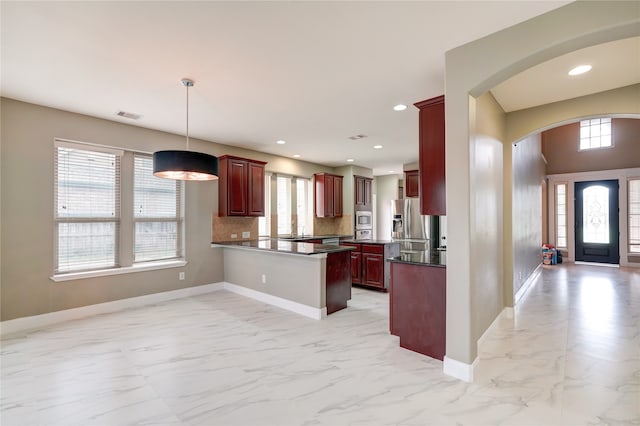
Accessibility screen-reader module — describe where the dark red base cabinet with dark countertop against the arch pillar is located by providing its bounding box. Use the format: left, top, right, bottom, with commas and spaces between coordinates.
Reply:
388, 249, 447, 361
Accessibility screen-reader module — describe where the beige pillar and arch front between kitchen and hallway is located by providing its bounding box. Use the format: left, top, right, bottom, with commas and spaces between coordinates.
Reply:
445, 1, 640, 371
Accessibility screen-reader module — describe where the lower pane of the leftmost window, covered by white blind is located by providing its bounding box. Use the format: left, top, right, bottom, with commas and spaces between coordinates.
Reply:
56, 222, 118, 272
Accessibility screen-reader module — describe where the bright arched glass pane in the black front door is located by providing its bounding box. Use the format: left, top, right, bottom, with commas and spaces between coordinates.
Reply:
582, 185, 609, 244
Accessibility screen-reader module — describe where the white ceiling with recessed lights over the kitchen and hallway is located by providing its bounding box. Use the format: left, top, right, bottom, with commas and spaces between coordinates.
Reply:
0, 0, 640, 175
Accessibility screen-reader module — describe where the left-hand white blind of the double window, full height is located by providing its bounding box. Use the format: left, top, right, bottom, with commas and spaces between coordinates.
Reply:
54, 143, 121, 272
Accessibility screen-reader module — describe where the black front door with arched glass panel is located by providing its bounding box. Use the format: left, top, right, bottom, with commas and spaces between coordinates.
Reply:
575, 180, 620, 264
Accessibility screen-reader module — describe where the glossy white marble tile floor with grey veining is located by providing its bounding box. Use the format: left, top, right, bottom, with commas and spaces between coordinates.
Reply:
0, 264, 640, 426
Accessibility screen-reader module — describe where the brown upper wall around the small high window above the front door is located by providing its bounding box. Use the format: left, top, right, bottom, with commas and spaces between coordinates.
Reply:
542, 117, 640, 174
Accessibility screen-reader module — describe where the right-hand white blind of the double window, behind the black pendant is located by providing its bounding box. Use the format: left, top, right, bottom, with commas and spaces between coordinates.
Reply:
133, 153, 182, 262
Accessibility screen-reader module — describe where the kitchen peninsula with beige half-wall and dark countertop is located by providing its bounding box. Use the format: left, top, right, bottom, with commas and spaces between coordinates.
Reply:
211, 238, 353, 319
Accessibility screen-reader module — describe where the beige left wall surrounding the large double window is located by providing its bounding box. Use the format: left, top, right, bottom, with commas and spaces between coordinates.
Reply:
0, 98, 344, 321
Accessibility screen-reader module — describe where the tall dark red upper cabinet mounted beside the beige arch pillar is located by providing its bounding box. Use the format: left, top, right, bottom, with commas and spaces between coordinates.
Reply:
414, 95, 447, 216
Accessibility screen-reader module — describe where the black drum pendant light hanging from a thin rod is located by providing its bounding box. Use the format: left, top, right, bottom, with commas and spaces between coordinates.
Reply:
153, 78, 218, 180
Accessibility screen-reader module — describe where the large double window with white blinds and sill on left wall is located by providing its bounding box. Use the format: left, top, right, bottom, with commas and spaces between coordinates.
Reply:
52, 140, 185, 281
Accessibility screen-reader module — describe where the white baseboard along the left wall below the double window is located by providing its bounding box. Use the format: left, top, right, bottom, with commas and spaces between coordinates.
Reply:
0, 283, 224, 337
